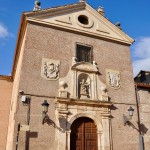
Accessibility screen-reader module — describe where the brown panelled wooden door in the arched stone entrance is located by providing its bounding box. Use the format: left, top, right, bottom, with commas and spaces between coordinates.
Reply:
70, 117, 97, 150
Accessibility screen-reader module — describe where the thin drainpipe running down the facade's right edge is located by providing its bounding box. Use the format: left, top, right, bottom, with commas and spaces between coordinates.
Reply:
135, 86, 144, 150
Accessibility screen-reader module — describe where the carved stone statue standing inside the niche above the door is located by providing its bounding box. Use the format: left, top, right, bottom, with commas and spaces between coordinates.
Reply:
80, 79, 89, 98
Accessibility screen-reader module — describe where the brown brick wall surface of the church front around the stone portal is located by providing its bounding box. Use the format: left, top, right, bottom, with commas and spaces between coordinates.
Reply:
14, 24, 139, 150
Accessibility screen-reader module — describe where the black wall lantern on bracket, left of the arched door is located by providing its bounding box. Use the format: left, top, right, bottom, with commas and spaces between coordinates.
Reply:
41, 100, 49, 124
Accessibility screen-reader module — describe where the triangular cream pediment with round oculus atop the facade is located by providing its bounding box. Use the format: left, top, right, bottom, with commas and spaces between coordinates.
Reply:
26, 2, 134, 44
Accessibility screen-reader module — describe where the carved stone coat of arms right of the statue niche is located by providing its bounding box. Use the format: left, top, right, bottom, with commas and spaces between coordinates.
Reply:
106, 70, 120, 89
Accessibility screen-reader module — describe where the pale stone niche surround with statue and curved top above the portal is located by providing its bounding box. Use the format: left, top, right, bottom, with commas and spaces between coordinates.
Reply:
59, 58, 108, 101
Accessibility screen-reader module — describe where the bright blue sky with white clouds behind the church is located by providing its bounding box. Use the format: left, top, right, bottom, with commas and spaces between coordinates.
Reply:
0, 0, 150, 76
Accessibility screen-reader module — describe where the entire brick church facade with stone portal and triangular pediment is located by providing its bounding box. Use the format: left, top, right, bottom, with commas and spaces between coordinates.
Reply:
1, 2, 145, 150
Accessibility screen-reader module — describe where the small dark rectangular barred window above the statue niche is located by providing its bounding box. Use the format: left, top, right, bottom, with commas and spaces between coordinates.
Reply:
76, 44, 93, 63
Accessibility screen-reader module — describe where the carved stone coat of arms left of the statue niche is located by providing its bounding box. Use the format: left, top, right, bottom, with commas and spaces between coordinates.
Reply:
41, 58, 60, 80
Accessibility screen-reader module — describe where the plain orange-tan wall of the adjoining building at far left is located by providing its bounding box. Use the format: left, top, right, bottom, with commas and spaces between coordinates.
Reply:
0, 76, 13, 150
